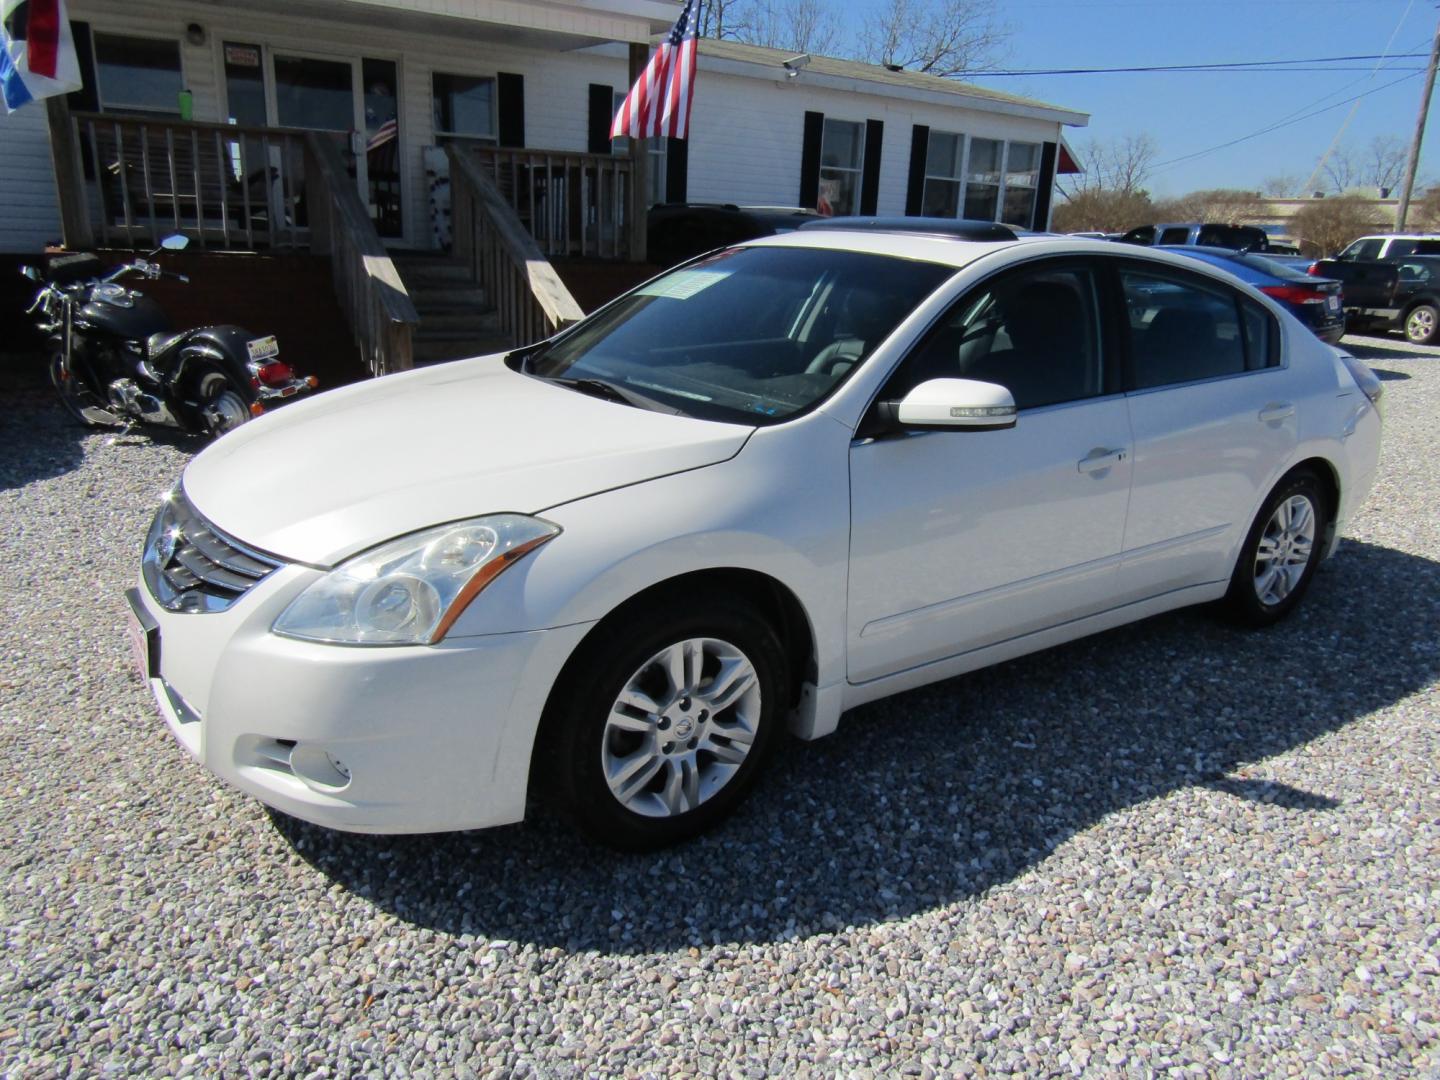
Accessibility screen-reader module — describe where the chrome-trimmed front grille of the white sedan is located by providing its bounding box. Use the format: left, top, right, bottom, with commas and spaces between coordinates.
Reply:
143, 491, 284, 613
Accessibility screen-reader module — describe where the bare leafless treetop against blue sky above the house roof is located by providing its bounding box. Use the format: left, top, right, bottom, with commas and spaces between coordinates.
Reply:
860, 0, 1011, 78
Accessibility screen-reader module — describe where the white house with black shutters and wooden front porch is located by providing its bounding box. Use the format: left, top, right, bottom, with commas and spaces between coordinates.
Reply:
0, 0, 1087, 367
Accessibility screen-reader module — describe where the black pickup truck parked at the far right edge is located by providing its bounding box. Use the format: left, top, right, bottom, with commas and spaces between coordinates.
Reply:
1310, 255, 1440, 346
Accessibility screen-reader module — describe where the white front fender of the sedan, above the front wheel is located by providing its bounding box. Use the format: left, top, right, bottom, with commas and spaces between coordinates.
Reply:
451, 413, 850, 687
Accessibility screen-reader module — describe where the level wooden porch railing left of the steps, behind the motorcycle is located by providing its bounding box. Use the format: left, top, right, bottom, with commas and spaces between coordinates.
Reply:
64, 112, 321, 251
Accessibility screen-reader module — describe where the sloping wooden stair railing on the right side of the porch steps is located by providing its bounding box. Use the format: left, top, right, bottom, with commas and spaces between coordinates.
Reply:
445, 145, 585, 346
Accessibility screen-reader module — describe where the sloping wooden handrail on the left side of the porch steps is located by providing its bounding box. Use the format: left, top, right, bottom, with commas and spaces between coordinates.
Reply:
305, 132, 420, 376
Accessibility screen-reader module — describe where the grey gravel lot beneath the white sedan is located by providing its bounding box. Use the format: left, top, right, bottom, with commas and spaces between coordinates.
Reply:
0, 338, 1440, 1077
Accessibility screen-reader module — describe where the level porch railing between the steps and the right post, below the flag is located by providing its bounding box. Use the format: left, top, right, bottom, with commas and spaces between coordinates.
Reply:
467, 147, 634, 259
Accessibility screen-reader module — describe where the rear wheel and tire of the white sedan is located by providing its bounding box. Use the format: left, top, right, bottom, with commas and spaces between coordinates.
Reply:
1224, 469, 1332, 626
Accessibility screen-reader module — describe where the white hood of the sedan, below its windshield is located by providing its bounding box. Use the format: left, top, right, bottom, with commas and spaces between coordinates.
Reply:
184, 357, 755, 566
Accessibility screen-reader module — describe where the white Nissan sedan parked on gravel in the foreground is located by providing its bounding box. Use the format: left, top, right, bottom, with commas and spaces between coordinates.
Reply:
130, 226, 1381, 848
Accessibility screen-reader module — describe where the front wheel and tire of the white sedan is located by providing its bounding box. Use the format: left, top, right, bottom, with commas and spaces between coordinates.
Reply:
533, 589, 789, 851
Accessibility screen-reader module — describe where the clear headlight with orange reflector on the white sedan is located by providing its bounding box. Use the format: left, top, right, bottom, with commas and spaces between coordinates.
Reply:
271, 514, 560, 645
